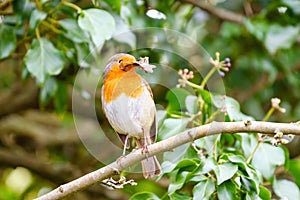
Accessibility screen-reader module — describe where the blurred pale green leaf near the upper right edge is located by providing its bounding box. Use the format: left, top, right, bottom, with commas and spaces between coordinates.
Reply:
264, 24, 299, 54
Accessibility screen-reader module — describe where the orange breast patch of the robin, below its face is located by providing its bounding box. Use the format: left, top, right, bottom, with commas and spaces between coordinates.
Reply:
103, 68, 144, 103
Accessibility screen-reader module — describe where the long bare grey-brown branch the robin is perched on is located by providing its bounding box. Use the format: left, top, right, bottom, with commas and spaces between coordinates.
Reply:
36, 121, 300, 200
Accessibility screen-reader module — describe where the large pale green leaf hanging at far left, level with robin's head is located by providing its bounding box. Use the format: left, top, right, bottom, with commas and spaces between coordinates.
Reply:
24, 38, 65, 83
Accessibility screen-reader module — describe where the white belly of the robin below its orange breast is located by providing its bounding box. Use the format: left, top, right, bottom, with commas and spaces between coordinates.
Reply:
102, 89, 156, 137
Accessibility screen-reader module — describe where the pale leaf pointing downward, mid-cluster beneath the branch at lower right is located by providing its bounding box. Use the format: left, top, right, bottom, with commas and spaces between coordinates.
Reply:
214, 163, 238, 185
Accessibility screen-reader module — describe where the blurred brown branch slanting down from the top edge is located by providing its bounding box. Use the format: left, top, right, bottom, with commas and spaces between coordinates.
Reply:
181, 0, 245, 24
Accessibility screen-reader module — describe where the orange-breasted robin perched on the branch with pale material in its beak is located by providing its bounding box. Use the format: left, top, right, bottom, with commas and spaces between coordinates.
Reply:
101, 53, 161, 178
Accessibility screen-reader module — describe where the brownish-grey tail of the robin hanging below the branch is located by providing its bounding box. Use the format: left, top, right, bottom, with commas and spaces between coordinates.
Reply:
142, 156, 161, 178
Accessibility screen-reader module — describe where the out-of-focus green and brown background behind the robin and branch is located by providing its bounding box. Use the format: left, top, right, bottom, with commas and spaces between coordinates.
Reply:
0, 0, 300, 200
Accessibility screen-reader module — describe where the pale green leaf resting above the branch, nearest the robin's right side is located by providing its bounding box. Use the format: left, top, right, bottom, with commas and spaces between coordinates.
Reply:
158, 118, 189, 140
